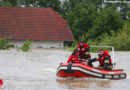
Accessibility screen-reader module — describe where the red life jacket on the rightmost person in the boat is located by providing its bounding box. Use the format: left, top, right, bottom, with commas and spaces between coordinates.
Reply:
98, 51, 112, 67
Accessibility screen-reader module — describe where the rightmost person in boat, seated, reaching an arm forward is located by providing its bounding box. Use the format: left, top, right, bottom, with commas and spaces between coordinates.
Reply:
88, 49, 113, 70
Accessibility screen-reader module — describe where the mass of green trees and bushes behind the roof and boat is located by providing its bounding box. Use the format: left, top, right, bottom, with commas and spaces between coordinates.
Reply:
0, 0, 130, 51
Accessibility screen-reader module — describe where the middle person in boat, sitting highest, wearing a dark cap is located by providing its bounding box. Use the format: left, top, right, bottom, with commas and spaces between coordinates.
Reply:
77, 40, 91, 60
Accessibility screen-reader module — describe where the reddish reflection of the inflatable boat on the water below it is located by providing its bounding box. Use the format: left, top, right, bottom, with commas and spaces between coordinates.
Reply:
56, 78, 111, 90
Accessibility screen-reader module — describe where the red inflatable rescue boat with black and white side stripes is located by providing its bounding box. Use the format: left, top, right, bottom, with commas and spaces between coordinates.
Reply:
57, 63, 126, 79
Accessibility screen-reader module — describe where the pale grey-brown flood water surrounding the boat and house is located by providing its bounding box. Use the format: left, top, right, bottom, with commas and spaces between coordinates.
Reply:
0, 49, 130, 90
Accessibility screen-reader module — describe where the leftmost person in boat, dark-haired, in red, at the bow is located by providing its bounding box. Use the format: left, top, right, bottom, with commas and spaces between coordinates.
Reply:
67, 49, 80, 63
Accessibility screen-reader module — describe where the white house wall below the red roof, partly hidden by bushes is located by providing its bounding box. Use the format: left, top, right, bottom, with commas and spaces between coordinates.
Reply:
9, 40, 64, 48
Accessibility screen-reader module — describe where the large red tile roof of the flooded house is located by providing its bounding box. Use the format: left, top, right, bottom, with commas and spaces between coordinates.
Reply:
0, 7, 74, 41
